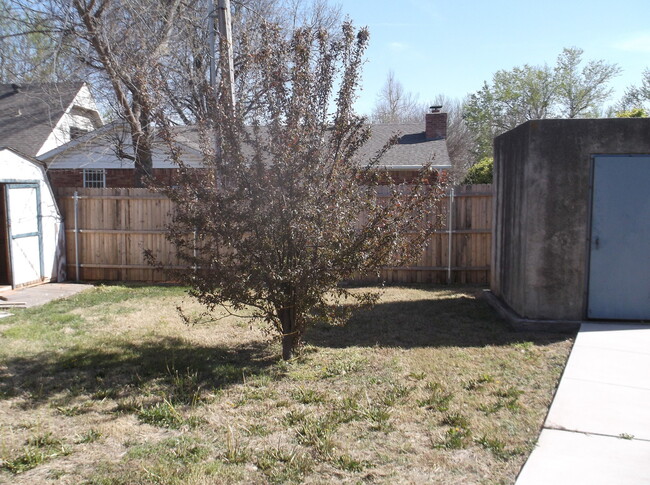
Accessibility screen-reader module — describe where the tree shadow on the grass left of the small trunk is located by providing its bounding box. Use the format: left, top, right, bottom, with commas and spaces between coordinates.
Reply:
0, 337, 277, 406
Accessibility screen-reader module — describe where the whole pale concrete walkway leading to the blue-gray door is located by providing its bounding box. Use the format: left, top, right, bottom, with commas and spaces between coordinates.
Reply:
516, 324, 650, 485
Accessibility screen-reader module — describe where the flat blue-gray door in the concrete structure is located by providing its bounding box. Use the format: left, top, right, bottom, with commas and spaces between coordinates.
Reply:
587, 155, 650, 320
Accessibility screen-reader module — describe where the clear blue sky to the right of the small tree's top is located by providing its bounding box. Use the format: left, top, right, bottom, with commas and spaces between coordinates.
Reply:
341, 0, 650, 114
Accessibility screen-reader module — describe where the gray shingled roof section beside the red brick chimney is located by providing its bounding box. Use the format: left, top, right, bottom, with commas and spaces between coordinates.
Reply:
359, 123, 451, 168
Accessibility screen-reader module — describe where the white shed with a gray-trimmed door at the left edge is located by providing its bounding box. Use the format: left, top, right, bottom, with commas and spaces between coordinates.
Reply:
0, 147, 66, 288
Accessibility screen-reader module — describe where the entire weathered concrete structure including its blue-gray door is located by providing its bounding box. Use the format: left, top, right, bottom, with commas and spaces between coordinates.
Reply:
491, 119, 650, 326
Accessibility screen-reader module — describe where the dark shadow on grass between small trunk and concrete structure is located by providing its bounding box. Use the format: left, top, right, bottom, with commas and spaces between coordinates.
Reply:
305, 296, 569, 348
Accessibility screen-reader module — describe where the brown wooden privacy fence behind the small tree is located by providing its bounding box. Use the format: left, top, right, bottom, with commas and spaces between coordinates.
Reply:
57, 185, 492, 284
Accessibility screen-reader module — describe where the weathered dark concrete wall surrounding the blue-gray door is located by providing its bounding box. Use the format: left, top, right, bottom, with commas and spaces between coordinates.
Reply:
491, 119, 650, 320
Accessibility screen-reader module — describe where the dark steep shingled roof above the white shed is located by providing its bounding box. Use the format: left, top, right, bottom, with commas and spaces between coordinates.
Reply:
0, 82, 84, 156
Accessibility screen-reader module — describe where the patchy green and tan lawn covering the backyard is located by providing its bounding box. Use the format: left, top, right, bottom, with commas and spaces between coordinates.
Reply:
0, 286, 572, 485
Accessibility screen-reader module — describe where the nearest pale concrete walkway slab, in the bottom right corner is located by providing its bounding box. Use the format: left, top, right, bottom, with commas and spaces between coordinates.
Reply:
517, 429, 650, 485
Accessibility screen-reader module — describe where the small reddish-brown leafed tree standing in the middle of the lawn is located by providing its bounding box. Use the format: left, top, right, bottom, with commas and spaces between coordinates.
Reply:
152, 24, 440, 359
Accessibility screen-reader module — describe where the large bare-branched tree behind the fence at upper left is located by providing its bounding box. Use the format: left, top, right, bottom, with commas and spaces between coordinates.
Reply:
6, 0, 340, 187
